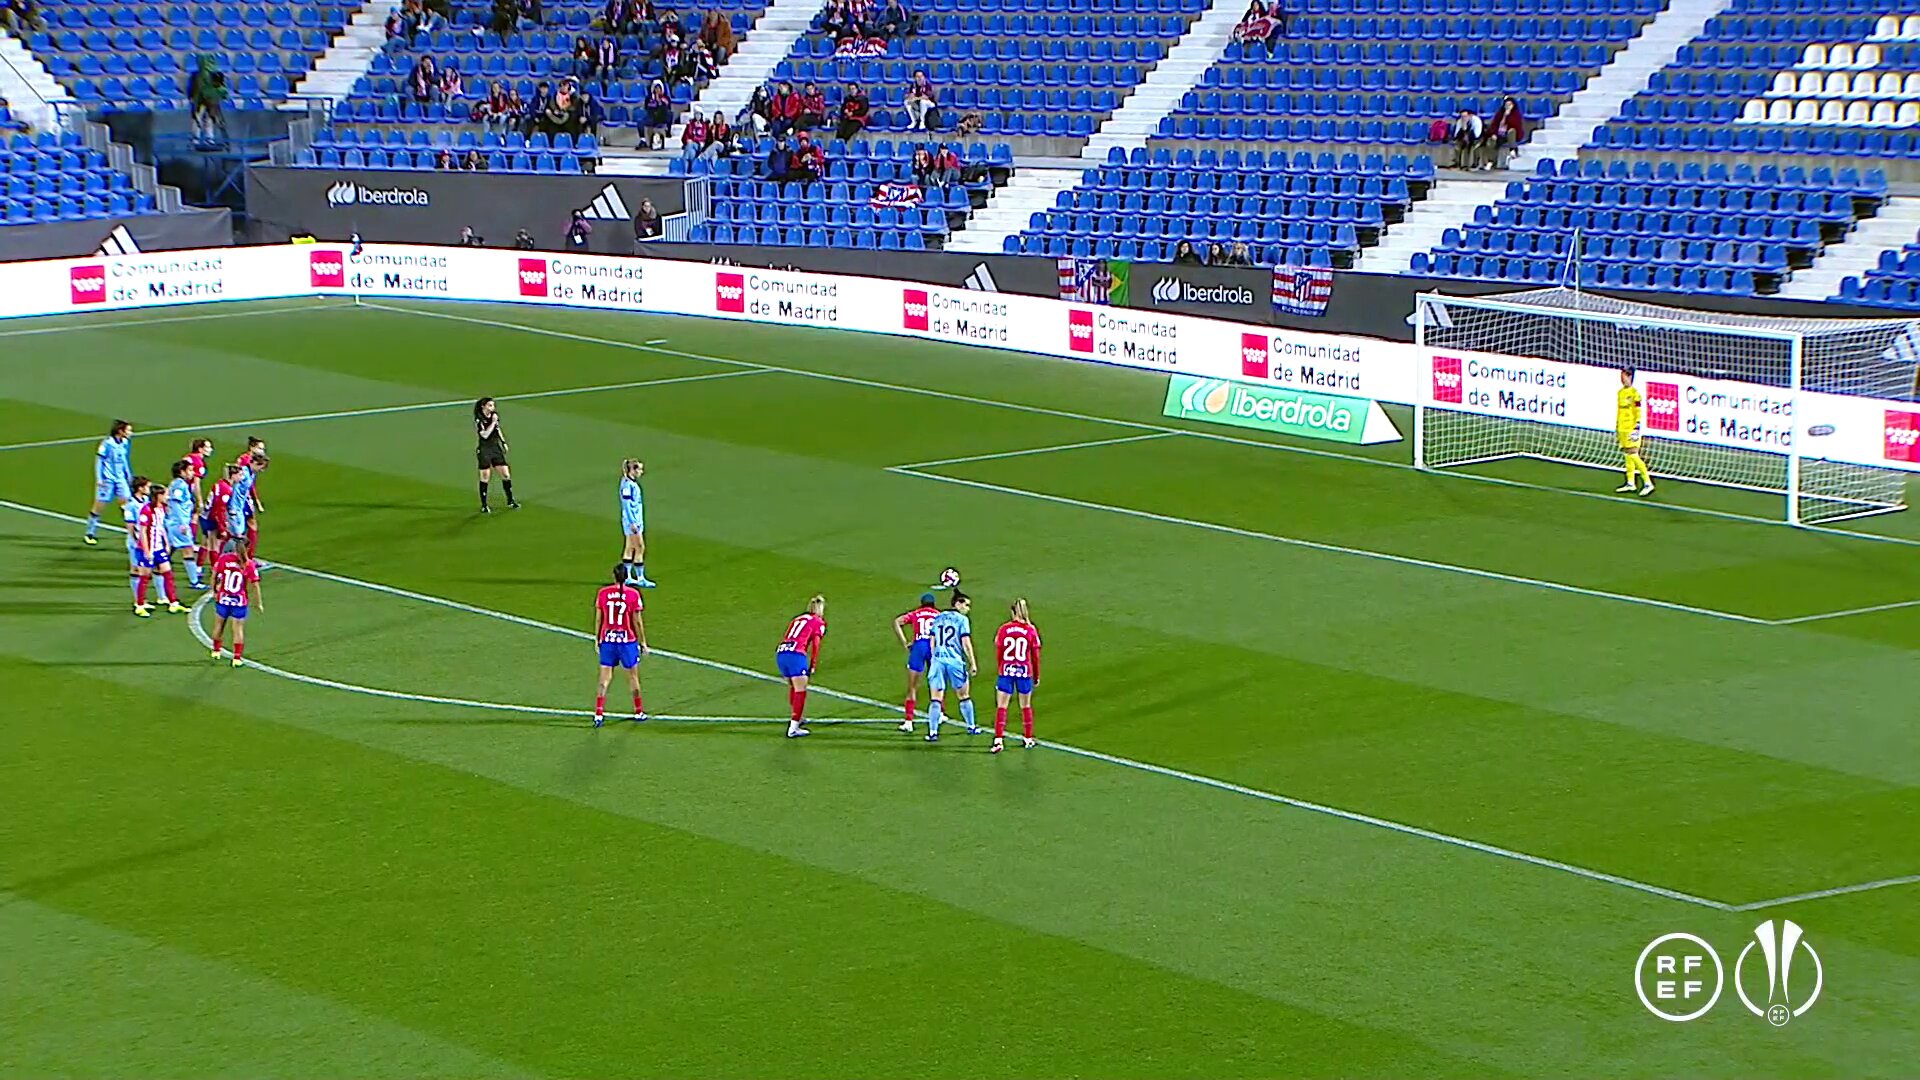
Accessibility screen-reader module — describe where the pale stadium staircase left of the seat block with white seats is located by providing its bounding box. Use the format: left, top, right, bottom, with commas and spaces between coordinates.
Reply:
1359, 0, 1728, 273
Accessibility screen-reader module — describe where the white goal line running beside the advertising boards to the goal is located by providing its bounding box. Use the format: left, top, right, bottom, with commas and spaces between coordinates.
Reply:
361, 304, 1920, 548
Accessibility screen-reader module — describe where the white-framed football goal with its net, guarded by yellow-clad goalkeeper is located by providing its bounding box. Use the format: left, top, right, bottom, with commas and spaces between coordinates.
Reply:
1413, 288, 1920, 523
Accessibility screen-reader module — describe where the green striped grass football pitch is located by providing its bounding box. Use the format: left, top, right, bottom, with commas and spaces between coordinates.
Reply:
0, 294, 1920, 1078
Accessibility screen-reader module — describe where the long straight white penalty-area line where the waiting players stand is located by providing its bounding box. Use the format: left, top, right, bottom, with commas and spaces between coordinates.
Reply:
0, 500, 1734, 911
